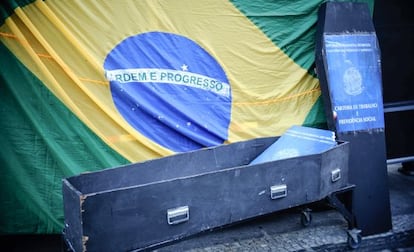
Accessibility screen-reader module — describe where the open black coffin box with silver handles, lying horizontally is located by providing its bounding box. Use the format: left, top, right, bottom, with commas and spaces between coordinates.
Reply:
63, 137, 349, 252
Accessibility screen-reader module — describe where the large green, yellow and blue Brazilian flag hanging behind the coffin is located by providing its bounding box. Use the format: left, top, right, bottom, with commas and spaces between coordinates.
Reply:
0, 0, 373, 234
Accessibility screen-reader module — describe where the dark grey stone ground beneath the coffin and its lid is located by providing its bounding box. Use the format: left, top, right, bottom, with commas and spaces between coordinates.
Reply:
0, 162, 414, 252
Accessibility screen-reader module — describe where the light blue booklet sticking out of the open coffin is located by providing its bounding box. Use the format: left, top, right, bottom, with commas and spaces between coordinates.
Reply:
250, 126, 337, 164
